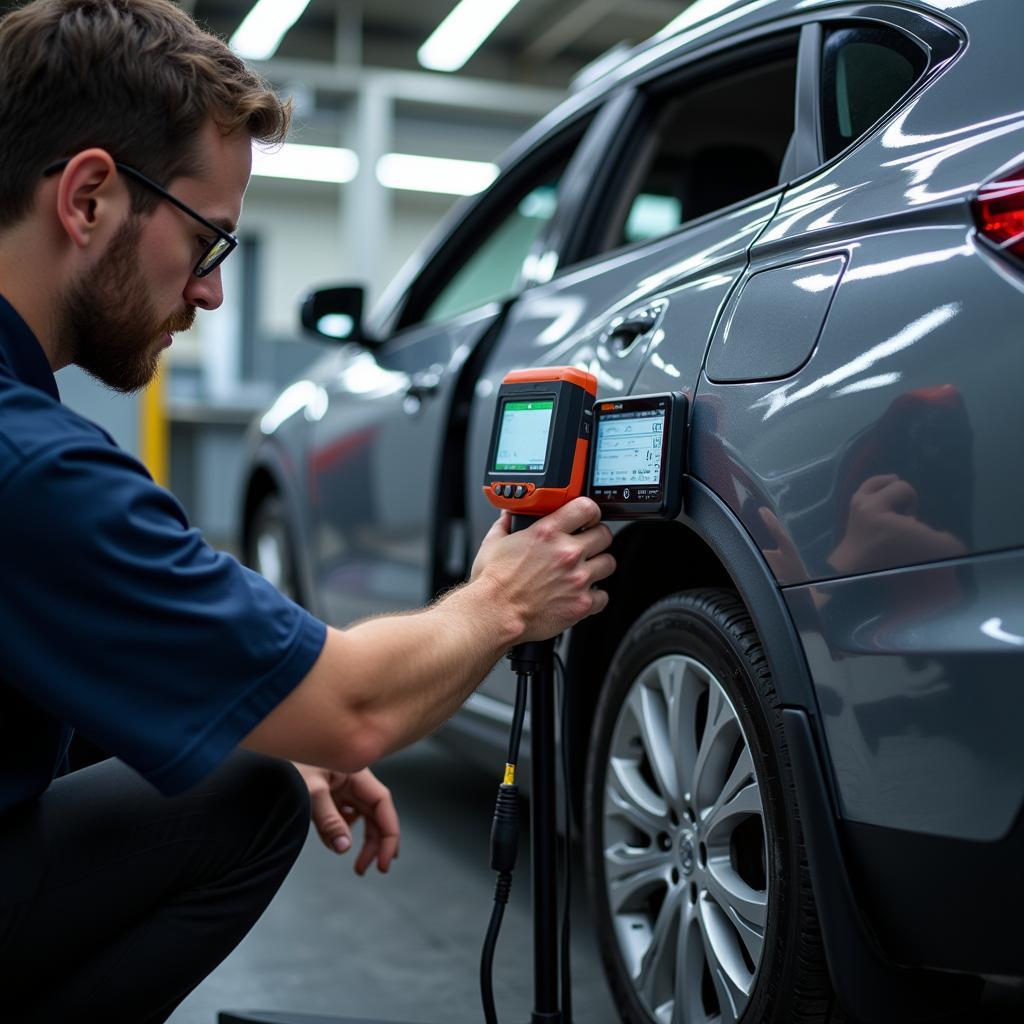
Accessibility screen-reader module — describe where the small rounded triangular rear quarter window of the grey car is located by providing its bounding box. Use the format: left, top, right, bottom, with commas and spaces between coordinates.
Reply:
821, 26, 927, 160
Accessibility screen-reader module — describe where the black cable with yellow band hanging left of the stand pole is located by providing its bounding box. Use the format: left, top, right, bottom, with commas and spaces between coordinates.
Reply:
480, 672, 529, 1024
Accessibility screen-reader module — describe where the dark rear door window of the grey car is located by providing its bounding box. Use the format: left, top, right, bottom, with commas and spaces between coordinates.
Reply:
603, 38, 797, 249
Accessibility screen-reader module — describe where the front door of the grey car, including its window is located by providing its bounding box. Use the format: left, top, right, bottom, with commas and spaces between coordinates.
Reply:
307, 121, 587, 624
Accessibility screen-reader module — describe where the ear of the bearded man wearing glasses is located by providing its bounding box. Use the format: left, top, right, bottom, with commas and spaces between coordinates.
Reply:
56, 148, 130, 249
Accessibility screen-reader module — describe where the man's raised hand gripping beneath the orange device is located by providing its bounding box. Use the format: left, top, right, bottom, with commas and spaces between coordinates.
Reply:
470, 498, 615, 640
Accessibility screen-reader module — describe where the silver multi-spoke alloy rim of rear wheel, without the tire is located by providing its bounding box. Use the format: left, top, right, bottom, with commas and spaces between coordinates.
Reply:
603, 654, 770, 1024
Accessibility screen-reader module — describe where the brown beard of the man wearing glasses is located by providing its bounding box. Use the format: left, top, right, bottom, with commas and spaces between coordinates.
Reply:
60, 217, 196, 394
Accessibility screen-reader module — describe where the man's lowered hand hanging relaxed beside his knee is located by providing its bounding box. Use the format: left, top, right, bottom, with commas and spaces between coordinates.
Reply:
295, 762, 399, 874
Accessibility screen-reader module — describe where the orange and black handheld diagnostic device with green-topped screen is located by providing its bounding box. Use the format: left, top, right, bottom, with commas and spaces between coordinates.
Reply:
483, 367, 597, 516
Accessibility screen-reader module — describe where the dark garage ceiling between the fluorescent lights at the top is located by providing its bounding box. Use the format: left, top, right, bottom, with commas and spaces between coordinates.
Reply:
188, 0, 690, 88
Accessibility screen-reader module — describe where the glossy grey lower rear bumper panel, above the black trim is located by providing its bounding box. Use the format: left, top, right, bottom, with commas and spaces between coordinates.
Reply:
784, 551, 1024, 842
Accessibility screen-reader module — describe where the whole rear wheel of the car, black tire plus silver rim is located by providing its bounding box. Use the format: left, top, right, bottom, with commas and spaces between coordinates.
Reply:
584, 590, 847, 1024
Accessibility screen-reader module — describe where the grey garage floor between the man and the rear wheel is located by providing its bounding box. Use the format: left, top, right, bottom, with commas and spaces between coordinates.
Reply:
170, 740, 617, 1024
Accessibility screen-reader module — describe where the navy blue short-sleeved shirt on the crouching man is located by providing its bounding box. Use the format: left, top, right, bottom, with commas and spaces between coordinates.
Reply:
0, 297, 326, 813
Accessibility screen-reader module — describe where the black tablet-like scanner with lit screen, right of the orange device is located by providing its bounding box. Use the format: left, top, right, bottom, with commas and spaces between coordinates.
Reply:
586, 391, 686, 519
